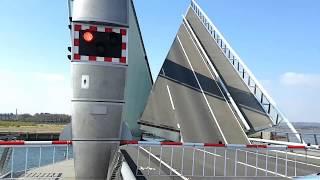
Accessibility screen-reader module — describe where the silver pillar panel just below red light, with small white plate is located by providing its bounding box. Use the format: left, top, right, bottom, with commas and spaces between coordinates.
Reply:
71, 63, 126, 101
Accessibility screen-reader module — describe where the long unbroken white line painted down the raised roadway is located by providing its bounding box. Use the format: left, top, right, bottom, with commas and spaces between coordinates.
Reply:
177, 35, 228, 144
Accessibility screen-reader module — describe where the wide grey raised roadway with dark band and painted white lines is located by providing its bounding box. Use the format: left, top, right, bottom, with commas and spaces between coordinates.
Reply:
141, 25, 249, 144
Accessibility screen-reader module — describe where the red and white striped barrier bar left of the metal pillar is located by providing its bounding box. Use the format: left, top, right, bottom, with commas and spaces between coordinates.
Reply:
0, 141, 72, 146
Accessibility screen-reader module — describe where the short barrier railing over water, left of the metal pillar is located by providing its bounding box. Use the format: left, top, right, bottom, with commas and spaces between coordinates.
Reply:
0, 141, 73, 179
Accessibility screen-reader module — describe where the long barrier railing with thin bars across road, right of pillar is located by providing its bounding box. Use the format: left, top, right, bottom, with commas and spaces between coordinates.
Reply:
121, 141, 320, 179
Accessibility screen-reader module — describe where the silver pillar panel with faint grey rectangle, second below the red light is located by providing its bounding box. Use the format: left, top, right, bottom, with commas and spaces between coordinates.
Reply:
72, 102, 123, 140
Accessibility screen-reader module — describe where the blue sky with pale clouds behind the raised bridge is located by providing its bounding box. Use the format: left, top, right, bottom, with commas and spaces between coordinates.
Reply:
0, 0, 320, 122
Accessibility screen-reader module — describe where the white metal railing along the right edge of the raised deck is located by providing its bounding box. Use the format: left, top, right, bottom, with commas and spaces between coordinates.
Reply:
190, 0, 303, 141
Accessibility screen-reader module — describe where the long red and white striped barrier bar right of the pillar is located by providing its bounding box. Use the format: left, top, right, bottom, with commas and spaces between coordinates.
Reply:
120, 141, 309, 149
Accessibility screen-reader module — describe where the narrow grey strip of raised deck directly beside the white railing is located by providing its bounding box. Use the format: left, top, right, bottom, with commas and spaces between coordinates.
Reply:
186, 9, 272, 130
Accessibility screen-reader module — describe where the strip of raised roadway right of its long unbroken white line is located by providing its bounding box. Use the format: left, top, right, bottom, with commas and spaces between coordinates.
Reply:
178, 25, 250, 144
